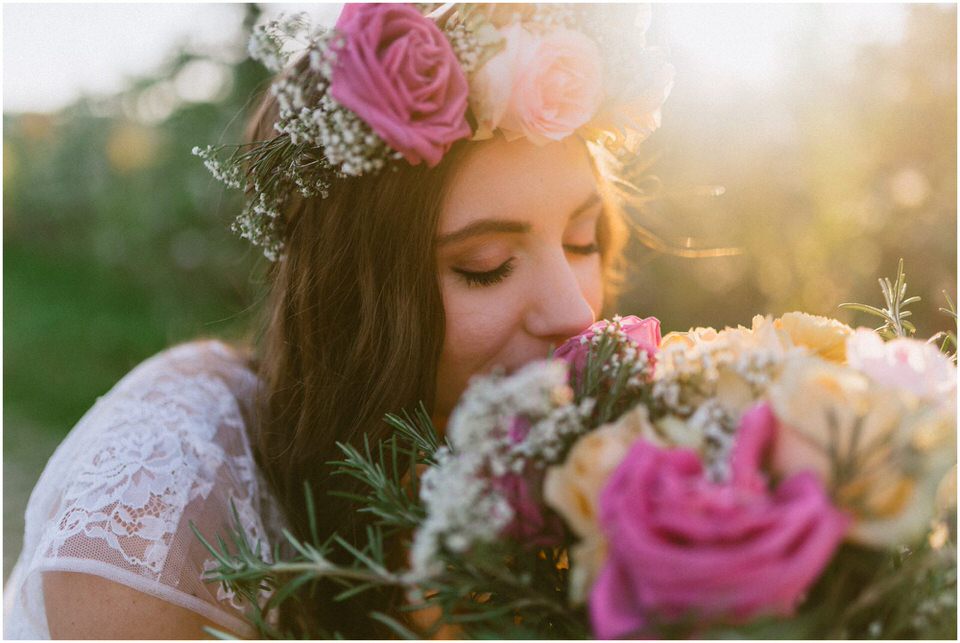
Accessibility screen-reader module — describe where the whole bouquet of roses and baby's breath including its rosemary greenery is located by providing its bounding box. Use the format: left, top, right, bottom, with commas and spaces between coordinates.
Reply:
201, 266, 957, 638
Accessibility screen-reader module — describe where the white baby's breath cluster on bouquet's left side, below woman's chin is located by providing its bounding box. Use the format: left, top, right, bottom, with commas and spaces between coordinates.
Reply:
411, 360, 593, 578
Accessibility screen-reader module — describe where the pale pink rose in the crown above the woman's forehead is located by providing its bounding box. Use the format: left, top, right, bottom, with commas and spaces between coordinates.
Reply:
471, 23, 603, 145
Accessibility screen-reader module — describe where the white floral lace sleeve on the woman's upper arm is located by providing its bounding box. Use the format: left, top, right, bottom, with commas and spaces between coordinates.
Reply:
35, 342, 274, 629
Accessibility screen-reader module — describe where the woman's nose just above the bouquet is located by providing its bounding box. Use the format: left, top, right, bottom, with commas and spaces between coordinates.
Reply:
526, 254, 597, 346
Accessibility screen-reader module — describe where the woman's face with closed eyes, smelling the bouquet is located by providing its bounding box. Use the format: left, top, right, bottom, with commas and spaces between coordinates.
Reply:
434, 137, 603, 424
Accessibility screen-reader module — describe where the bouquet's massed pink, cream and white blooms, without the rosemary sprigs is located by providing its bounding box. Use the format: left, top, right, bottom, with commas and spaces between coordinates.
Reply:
402, 313, 956, 638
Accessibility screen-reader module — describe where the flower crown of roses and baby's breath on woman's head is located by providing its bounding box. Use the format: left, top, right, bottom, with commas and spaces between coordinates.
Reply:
193, 3, 673, 261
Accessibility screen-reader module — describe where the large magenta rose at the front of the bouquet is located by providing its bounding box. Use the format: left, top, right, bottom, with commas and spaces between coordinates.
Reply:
590, 404, 849, 638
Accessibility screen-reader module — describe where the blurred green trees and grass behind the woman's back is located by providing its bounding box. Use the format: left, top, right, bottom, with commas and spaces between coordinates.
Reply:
3, 5, 269, 432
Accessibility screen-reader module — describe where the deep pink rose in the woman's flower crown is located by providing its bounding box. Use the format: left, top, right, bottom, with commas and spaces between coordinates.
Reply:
330, 4, 470, 167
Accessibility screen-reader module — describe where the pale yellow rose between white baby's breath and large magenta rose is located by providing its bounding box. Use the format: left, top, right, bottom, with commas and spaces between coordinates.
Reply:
543, 406, 657, 602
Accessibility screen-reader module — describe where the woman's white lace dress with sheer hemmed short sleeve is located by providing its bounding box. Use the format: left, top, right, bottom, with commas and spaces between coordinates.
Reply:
3, 340, 282, 639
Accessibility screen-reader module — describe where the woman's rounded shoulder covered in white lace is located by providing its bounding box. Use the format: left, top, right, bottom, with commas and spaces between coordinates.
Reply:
28, 340, 268, 556
